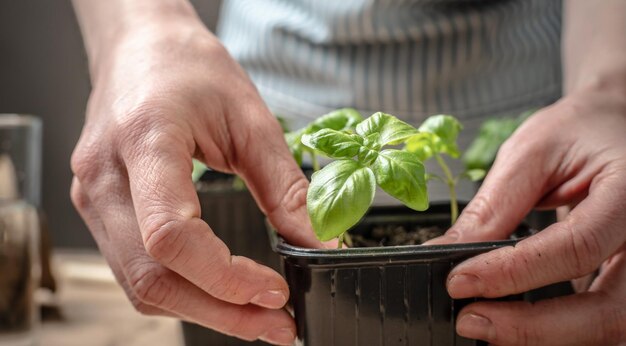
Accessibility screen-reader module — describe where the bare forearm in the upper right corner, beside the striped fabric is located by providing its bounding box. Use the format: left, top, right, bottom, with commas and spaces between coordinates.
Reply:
563, 0, 626, 98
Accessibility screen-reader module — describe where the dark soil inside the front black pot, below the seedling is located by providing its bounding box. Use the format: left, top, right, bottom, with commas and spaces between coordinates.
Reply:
350, 225, 445, 247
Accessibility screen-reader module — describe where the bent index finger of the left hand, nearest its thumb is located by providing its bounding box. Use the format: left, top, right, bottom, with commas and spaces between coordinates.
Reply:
117, 123, 289, 309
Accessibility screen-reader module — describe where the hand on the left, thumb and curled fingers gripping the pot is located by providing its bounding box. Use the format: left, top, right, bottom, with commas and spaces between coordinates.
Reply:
71, 16, 322, 344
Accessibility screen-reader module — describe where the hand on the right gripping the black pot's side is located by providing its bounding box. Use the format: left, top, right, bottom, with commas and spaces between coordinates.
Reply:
432, 90, 626, 345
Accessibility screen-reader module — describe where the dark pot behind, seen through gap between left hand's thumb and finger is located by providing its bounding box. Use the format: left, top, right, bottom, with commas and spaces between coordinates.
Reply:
183, 171, 280, 346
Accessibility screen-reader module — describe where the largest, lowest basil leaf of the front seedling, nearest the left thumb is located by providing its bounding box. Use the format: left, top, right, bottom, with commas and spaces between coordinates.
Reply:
306, 160, 376, 241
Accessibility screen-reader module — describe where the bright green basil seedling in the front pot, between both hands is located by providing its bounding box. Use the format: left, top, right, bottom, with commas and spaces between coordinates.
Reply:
300, 112, 428, 246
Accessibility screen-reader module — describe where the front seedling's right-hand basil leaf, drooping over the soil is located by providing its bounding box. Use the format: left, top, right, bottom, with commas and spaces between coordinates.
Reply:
371, 149, 428, 211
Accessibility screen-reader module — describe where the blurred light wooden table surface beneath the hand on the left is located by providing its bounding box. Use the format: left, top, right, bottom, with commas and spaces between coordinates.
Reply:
40, 250, 183, 346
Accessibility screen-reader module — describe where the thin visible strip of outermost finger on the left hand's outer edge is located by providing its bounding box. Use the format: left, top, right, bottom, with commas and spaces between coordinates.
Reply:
70, 177, 173, 317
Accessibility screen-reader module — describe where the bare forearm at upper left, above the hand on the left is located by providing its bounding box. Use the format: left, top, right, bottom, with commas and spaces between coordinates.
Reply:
72, 0, 203, 78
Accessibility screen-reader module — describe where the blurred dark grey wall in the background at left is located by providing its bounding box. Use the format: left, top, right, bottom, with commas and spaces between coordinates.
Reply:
0, 0, 218, 247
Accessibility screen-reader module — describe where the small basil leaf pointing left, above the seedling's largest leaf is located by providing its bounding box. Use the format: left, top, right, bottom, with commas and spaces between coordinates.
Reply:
302, 129, 361, 159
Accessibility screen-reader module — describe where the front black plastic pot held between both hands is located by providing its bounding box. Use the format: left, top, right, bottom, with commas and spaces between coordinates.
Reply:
271, 205, 529, 346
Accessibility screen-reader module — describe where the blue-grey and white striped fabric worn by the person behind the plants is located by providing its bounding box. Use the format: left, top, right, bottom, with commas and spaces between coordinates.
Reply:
218, 0, 561, 130
